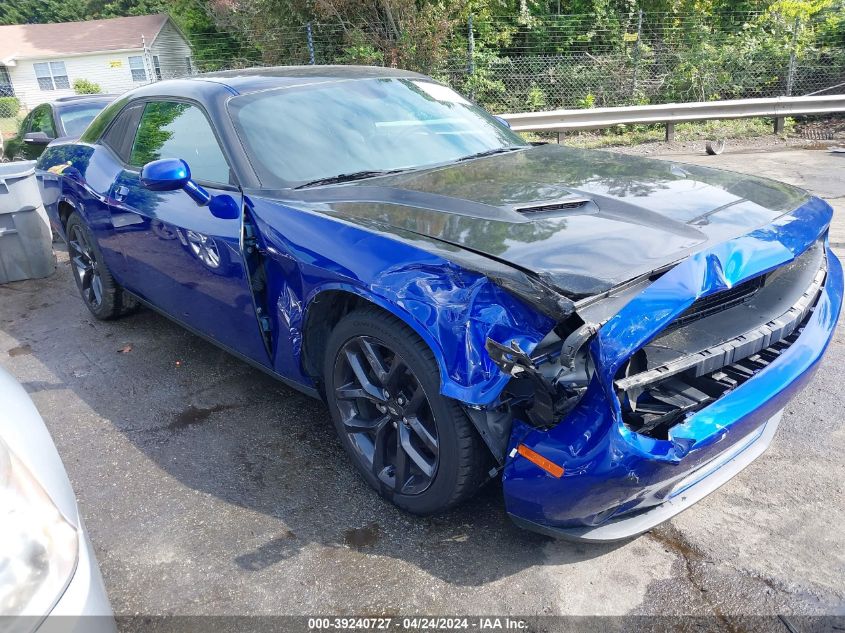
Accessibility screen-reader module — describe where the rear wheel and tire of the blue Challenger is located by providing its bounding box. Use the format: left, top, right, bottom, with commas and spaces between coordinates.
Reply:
66, 211, 138, 321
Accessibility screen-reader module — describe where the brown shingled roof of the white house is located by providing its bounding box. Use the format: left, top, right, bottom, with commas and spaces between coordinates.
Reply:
0, 13, 168, 64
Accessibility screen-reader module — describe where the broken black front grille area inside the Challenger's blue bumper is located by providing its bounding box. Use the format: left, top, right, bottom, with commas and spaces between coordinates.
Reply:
614, 245, 827, 439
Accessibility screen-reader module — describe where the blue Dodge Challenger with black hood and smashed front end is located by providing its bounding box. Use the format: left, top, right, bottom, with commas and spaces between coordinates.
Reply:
39, 66, 843, 541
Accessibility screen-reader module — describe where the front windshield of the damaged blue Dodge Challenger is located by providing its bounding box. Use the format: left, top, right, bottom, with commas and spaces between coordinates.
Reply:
229, 79, 527, 187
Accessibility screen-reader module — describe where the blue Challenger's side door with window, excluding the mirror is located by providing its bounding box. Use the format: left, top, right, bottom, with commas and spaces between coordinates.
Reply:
110, 100, 269, 365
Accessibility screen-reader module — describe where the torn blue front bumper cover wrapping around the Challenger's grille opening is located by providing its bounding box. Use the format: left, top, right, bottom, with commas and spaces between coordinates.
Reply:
504, 198, 843, 536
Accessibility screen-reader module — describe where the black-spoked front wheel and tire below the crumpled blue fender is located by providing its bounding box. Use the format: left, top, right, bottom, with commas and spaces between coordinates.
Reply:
323, 309, 490, 515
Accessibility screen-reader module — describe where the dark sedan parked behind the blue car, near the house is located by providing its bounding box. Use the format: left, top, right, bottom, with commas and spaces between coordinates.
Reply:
2, 95, 115, 160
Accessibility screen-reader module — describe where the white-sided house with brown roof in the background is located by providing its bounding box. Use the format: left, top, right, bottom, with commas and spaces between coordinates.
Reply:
0, 14, 194, 110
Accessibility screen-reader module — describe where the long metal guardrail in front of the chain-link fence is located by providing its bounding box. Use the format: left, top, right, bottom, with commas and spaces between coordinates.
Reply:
500, 95, 845, 141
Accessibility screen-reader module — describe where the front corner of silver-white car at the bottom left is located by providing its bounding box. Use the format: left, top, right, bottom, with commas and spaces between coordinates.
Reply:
0, 369, 116, 633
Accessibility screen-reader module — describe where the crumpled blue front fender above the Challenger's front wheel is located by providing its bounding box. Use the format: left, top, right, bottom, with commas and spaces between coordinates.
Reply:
251, 199, 555, 406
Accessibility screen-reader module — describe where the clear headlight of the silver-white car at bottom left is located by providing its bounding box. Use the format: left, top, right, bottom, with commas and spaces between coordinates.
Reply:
0, 440, 79, 616
